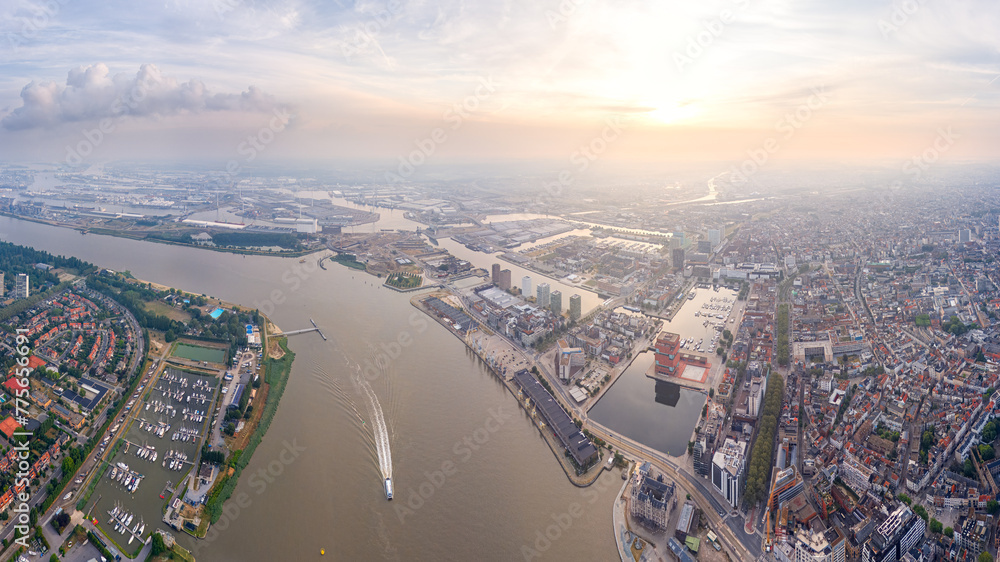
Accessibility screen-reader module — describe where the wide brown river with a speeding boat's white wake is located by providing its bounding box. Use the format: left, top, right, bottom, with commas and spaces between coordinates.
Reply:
0, 213, 621, 562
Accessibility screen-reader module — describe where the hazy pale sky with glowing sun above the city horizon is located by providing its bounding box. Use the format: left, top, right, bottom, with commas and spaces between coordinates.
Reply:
0, 0, 1000, 165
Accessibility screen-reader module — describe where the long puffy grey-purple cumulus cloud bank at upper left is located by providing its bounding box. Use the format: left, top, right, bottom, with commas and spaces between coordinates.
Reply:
0, 63, 280, 130
